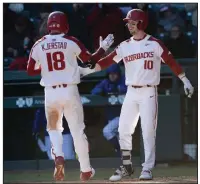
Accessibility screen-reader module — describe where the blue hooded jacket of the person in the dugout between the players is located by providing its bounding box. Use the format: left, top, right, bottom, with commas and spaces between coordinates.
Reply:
91, 64, 127, 95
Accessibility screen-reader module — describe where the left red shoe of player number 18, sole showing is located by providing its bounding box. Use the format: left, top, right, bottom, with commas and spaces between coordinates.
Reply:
54, 156, 65, 181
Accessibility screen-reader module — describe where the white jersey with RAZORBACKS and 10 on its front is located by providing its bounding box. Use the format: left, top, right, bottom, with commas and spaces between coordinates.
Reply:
113, 35, 167, 86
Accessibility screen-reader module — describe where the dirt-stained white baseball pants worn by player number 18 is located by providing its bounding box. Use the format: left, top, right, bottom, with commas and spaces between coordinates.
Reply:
45, 85, 91, 172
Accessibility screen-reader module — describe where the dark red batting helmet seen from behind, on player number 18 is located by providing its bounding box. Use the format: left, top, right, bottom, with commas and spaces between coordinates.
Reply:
47, 11, 69, 33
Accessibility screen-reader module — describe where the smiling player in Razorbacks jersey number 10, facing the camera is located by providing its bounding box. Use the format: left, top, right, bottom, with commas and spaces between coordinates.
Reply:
90, 9, 194, 181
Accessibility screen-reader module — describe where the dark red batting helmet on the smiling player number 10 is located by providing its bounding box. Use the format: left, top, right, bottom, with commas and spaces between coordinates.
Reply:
123, 9, 148, 30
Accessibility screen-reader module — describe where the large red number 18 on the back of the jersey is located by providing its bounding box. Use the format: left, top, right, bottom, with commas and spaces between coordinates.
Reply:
46, 52, 65, 72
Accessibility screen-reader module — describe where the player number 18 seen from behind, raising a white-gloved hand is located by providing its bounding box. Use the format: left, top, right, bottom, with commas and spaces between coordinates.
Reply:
27, 11, 114, 181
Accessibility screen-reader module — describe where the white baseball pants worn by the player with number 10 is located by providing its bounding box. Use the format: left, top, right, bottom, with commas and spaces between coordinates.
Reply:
118, 86, 158, 170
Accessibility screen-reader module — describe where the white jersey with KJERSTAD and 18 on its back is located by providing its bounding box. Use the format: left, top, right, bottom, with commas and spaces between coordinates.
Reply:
30, 34, 87, 86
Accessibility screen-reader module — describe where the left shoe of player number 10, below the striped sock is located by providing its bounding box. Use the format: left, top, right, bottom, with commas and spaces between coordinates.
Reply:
109, 164, 134, 181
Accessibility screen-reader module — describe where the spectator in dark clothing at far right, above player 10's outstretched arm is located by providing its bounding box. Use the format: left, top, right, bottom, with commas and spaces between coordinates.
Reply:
164, 25, 195, 58
